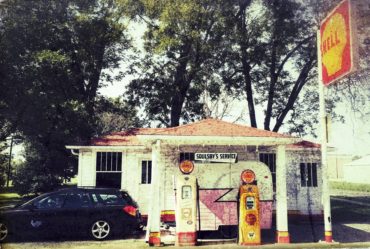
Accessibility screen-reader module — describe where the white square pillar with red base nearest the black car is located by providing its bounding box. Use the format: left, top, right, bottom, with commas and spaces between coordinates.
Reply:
145, 140, 162, 246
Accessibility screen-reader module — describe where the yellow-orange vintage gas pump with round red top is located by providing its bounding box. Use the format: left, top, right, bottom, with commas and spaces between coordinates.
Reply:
238, 170, 261, 245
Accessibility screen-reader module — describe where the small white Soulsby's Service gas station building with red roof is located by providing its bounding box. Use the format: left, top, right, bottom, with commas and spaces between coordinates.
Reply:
67, 119, 323, 245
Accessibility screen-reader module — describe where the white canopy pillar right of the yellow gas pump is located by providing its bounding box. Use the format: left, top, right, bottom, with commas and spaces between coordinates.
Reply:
276, 145, 290, 243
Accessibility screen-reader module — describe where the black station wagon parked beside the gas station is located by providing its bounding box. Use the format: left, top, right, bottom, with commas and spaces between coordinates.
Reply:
0, 188, 141, 241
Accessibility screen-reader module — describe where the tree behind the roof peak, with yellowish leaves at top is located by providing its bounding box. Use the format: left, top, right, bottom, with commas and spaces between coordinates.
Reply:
121, 0, 223, 126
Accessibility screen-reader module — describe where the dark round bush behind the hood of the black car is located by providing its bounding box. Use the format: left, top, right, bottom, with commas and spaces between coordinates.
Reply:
13, 163, 62, 195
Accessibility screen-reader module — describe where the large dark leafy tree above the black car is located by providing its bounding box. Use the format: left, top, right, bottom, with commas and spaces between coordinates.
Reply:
0, 0, 129, 194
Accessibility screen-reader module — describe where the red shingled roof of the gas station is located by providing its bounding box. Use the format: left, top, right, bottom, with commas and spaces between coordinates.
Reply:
91, 119, 293, 146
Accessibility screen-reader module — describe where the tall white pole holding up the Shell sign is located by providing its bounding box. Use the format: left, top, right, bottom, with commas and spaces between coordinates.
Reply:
317, 30, 333, 243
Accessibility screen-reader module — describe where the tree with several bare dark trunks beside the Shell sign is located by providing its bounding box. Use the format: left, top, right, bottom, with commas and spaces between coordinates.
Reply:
218, 0, 317, 136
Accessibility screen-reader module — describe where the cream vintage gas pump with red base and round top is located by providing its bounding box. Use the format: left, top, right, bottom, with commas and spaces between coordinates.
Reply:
175, 160, 198, 246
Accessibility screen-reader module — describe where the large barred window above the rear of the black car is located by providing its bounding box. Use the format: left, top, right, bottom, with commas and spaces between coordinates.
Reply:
96, 152, 122, 188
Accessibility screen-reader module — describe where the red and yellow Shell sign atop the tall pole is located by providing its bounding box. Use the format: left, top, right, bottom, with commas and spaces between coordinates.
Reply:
320, 0, 353, 85
